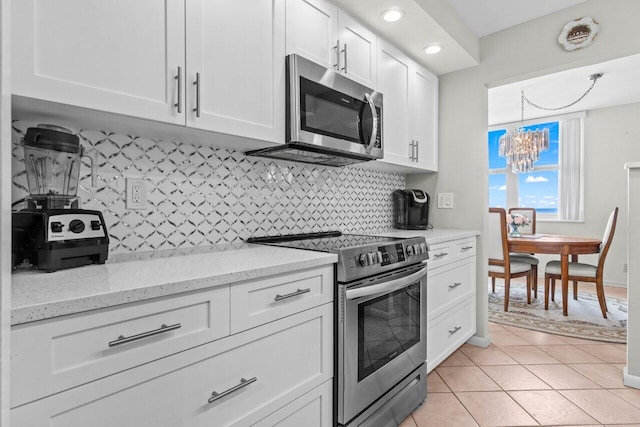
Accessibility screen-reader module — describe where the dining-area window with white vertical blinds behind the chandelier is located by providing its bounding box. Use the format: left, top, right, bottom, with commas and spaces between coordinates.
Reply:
488, 114, 584, 221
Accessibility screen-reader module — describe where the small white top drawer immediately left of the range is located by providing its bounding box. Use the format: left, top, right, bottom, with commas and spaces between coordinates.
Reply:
231, 265, 335, 333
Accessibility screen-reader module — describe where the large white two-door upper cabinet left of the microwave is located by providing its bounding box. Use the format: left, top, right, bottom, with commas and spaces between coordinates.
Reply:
12, 0, 285, 142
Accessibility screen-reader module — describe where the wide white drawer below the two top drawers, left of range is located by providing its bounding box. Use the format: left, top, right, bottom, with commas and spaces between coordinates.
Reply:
11, 304, 333, 427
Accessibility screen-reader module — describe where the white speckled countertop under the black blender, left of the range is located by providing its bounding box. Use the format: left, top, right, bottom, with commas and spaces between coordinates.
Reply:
11, 243, 338, 325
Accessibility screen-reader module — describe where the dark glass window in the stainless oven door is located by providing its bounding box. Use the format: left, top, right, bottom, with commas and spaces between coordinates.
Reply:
358, 282, 420, 381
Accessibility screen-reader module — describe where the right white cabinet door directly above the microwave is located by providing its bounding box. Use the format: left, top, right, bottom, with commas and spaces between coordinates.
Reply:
338, 13, 377, 88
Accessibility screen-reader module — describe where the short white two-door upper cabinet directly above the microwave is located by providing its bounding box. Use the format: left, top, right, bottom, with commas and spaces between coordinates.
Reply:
286, 0, 377, 88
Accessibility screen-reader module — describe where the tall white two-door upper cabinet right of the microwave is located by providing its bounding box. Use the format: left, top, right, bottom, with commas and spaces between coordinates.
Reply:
377, 41, 438, 172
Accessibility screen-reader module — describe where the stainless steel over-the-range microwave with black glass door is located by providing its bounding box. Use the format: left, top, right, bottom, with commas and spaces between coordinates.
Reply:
247, 54, 383, 166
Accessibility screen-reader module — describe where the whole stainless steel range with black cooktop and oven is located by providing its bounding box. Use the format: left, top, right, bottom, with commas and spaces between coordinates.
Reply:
247, 232, 428, 427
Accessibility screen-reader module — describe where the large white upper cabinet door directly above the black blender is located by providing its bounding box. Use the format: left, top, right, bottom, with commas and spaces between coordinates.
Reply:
11, 0, 185, 124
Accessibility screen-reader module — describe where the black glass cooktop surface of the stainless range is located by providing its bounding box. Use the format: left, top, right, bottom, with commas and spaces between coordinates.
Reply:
247, 231, 402, 252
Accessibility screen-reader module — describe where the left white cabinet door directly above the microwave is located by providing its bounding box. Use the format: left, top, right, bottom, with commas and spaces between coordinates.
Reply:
286, 0, 338, 70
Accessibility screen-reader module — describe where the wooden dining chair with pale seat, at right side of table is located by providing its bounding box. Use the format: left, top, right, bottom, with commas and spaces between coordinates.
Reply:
544, 208, 618, 319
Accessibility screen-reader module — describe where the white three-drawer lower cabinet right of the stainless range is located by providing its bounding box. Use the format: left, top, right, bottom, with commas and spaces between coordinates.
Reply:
427, 238, 476, 372
